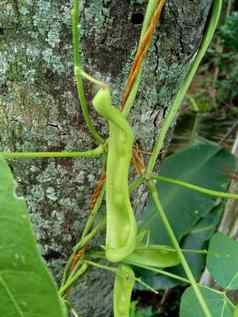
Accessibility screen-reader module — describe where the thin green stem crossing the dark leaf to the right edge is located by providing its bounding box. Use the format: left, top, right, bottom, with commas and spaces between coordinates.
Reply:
152, 176, 238, 200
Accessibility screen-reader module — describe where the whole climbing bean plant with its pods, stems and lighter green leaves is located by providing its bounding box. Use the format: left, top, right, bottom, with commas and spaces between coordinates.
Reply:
0, 0, 238, 317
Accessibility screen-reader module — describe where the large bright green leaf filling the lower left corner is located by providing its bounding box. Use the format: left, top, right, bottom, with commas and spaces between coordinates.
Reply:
0, 158, 67, 317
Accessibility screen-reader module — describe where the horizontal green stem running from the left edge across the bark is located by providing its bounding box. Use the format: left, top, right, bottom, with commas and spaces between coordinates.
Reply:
0, 145, 105, 159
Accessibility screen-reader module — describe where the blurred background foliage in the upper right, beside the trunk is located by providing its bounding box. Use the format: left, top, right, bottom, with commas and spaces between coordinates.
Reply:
170, 0, 238, 152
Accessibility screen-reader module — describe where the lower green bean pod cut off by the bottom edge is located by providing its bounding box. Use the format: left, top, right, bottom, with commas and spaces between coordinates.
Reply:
113, 265, 135, 317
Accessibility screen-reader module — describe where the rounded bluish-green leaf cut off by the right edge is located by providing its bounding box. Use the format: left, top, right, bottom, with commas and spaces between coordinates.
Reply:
207, 232, 238, 289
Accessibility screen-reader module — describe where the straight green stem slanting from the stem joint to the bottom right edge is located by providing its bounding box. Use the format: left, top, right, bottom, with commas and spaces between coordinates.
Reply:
147, 181, 212, 317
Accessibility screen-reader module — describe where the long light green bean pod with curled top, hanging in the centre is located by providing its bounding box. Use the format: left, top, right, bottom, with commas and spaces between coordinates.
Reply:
93, 87, 137, 262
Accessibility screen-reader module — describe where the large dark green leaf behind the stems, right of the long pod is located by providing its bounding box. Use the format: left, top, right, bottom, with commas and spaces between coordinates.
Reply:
142, 139, 234, 245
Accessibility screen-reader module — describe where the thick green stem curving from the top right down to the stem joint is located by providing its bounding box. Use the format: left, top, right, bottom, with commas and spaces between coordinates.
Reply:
145, 0, 222, 178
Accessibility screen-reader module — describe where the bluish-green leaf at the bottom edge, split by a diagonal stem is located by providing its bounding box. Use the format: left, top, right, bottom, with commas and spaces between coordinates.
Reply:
179, 287, 234, 317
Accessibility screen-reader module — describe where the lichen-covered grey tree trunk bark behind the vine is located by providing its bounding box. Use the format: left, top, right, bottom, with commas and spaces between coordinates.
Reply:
0, 0, 211, 317
